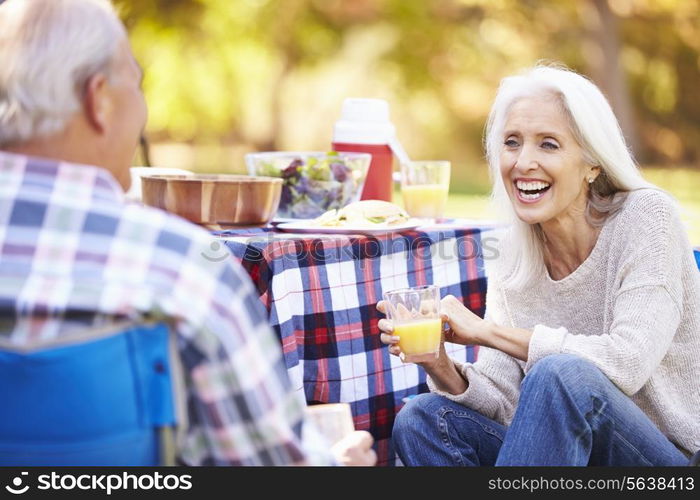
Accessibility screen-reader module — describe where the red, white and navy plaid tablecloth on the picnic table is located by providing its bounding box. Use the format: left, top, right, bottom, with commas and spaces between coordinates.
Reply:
216, 226, 487, 465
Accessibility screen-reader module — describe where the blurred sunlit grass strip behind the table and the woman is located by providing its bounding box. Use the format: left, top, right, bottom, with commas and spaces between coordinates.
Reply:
394, 168, 700, 247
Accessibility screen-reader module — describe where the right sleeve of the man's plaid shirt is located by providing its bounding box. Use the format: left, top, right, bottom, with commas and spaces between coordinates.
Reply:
156, 227, 320, 465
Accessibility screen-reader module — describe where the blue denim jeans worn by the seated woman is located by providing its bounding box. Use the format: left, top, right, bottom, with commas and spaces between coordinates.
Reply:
393, 354, 688, 466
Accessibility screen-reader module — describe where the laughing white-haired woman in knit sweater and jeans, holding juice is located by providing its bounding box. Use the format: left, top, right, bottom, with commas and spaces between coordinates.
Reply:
378, 67, 700, 466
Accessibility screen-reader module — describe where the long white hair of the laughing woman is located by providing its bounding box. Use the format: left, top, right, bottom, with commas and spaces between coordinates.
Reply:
484, 65, 653, 288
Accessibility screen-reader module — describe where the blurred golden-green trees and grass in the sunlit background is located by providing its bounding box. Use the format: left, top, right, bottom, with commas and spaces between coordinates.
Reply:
115, 0, 700, 245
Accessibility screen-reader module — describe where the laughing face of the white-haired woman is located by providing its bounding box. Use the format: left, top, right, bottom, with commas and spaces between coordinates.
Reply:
500, 94, 600, 224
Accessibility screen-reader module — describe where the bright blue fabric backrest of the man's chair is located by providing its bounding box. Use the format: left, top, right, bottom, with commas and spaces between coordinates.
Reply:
0, 323, 176, 466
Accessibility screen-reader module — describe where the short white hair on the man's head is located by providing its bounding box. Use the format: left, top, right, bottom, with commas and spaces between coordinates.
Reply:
0, 0, 126, 147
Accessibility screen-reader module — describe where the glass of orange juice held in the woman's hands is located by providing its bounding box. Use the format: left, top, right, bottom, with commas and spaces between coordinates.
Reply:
384, 285, 442, 363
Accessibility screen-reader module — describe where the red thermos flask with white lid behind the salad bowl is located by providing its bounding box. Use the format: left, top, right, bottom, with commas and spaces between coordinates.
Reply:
333, 98, 396, 201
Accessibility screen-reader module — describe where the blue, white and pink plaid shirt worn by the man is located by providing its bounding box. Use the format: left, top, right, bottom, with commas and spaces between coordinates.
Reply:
0, 152, 330, 465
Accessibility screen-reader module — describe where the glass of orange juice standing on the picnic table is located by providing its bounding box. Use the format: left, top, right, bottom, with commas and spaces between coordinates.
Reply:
401, 160, 451, 222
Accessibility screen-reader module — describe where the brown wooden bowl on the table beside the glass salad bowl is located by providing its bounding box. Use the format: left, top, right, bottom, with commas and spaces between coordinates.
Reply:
141, 174, 282, 229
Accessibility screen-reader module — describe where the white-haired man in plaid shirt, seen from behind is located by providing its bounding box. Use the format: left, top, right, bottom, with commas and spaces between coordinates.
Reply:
0, 0, 376, 465
